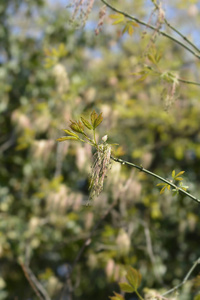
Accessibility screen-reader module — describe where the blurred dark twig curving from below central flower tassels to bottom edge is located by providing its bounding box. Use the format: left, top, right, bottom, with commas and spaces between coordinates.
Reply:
60, 198, 118, 299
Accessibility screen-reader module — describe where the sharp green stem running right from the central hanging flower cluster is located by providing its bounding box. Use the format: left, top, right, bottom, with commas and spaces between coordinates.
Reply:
110, 156, 200, 204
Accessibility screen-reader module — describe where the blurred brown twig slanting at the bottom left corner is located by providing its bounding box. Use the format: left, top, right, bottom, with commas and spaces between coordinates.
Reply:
19, 261, 51, 300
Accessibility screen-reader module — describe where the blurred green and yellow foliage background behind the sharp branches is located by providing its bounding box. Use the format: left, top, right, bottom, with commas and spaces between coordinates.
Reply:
0, 0, 200, 300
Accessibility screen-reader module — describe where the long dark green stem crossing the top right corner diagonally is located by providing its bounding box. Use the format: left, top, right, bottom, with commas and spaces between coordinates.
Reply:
101, 0, 200, 59
